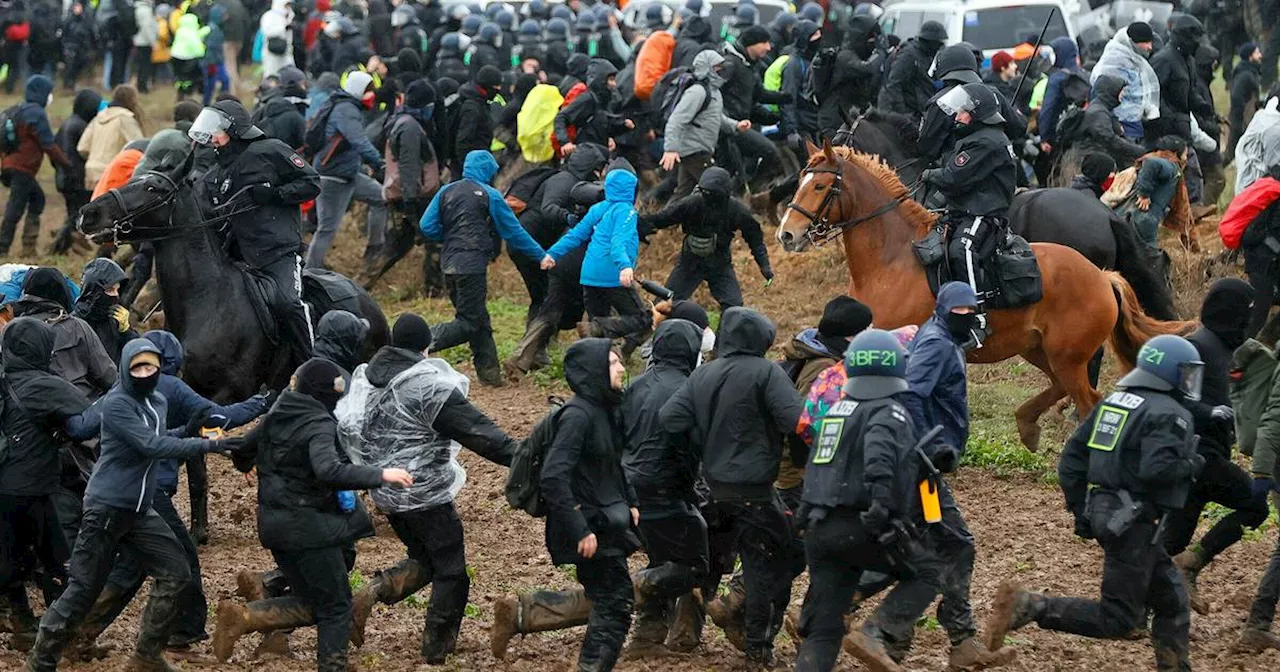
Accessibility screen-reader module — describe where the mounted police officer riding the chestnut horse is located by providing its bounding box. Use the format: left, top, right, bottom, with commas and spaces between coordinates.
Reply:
920, 82, 1018, 347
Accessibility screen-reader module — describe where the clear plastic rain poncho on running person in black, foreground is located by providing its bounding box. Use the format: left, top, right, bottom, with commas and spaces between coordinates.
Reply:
334, 358, 468, 513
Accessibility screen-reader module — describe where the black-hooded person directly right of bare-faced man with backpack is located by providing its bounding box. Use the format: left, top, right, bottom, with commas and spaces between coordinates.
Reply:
622, 317, 710, 652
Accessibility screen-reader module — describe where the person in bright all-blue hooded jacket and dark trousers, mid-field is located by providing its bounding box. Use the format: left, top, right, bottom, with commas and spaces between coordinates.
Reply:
543, 165, 652, 356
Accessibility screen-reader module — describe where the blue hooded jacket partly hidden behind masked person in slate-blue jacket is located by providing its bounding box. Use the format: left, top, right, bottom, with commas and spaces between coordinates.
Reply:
142, 329, 266, 494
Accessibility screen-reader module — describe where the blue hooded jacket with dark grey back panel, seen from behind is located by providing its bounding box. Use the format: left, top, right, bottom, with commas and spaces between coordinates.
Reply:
419, 150, 547, 275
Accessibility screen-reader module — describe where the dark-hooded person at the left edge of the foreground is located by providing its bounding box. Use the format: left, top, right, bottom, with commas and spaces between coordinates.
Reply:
0, 317, 101, 649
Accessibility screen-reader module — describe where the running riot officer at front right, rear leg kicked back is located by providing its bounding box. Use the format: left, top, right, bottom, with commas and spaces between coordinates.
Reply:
987, 335, 1204, 672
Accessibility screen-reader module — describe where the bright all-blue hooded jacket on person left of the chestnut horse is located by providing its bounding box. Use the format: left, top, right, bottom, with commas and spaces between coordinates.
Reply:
547, 170, 640, 287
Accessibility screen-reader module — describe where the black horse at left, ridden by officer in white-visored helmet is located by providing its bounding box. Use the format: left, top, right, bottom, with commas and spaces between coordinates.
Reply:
79, 157, 390, 403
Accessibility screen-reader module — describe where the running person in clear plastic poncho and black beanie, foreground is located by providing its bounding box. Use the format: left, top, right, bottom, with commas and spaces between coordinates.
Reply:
337, 314, 517, 664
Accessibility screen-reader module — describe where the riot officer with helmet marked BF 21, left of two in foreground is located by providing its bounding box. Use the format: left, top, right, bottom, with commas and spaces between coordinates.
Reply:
796, 329, 957, 672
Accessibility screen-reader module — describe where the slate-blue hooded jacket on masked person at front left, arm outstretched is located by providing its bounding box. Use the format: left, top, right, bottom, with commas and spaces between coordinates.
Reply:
84, 338, 211, 513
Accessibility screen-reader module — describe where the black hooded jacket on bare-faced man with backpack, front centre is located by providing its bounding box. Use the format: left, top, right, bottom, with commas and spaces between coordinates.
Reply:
540, 338, 639, 564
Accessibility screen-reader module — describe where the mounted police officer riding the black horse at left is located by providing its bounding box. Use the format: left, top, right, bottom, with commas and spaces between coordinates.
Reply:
187, 100, 320, 365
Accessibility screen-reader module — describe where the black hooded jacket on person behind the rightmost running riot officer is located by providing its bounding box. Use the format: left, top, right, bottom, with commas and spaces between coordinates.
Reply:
1184, 278, 1254, 458
